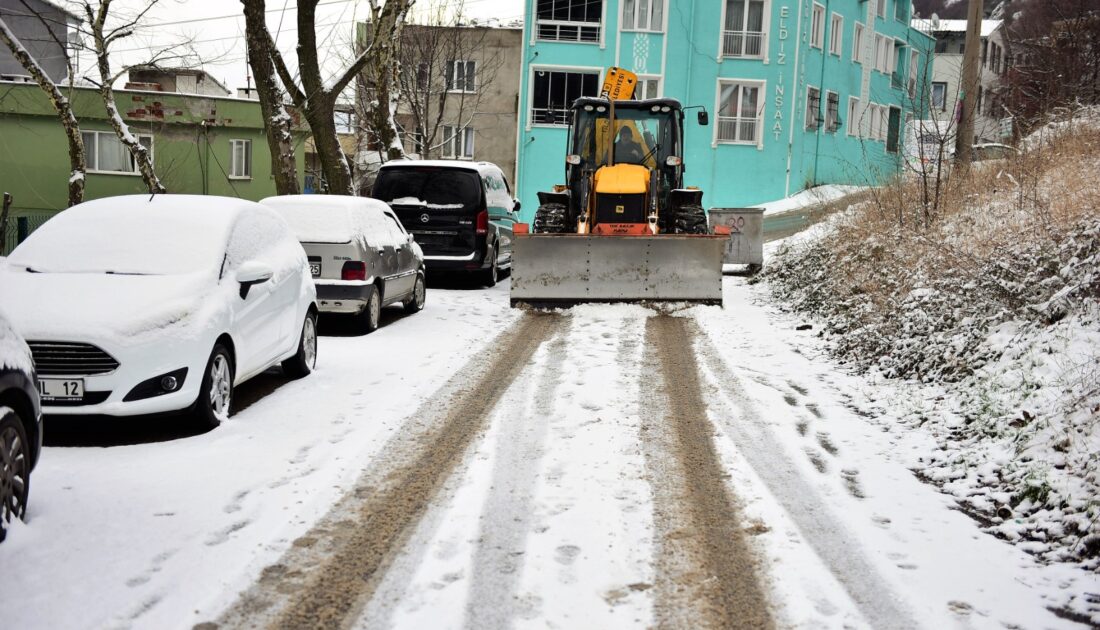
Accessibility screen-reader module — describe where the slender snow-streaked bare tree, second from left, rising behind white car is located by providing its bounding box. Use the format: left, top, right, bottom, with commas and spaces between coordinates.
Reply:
84, 0, 167, 194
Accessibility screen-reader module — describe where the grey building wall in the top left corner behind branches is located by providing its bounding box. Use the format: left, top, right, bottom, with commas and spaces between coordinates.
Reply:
0, 0, 75, 82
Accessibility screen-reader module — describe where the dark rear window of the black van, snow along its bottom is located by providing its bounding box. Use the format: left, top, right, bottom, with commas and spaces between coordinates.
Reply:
374, 167, 481, 208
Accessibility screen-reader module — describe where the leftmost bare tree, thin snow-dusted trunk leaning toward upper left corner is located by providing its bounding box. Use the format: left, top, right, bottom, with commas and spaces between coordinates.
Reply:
0, 0, 87, 206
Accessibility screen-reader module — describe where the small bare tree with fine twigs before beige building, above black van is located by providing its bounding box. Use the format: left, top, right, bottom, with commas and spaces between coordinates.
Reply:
387, 3, 504, 157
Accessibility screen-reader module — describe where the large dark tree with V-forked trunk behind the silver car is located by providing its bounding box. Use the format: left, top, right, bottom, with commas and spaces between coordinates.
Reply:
242, 0, 414, 195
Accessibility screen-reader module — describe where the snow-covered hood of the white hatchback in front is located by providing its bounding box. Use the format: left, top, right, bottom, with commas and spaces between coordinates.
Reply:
0, 268, 219, 346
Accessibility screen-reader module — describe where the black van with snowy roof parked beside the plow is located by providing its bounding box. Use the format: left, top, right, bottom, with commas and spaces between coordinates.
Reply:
372, 159, 519, 287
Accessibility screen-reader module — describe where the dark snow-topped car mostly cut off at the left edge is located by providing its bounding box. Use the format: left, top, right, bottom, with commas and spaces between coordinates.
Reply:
0, 307, 42, 541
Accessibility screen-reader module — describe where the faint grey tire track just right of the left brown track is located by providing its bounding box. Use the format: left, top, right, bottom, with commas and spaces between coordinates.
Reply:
464, 333, 570, 629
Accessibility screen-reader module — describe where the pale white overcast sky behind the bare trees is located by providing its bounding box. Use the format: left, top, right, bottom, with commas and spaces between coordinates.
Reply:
56, 0, 524, 99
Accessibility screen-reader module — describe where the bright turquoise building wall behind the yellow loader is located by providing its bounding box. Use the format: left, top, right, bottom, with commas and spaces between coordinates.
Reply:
517, 0, 932, 220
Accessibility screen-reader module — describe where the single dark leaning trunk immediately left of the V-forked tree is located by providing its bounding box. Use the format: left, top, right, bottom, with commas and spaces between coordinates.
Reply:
241, 0, 300, 195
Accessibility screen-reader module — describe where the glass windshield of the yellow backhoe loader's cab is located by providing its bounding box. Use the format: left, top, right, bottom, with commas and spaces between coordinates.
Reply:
573, 104, 680, 169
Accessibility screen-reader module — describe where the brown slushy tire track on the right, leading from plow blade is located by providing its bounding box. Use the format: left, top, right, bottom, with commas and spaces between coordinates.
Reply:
642, 314, 774, 629
